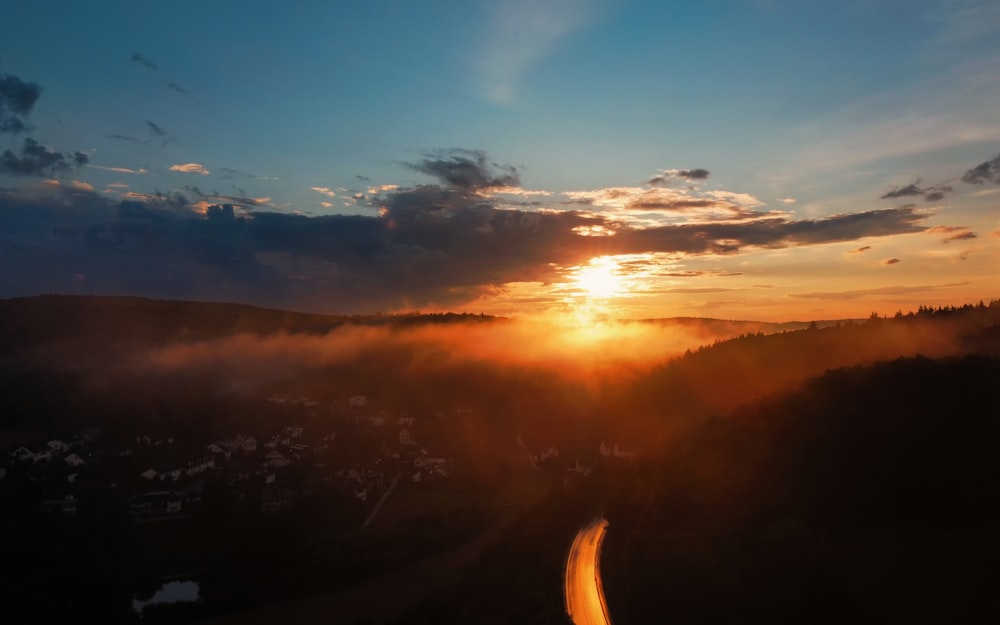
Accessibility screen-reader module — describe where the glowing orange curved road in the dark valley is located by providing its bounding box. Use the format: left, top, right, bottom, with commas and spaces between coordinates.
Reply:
565, 518, 611, 625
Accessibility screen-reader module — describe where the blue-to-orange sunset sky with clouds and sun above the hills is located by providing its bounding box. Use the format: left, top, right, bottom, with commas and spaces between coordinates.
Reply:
0, 0, 1000, 321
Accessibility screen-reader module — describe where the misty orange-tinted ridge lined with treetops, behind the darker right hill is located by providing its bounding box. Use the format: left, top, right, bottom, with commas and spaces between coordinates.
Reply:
629, 301, 1000, 417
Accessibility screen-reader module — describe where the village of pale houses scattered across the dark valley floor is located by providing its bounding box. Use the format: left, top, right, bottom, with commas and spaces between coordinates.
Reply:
0, 395, 633, 527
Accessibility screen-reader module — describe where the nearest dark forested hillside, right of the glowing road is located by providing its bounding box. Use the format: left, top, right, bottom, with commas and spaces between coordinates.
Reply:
602, 356, 1000, 623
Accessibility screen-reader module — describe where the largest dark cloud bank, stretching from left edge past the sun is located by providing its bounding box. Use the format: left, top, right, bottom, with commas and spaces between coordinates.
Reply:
0, 152, 927, 312
